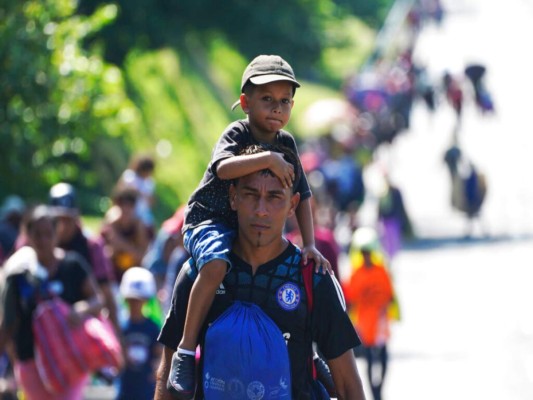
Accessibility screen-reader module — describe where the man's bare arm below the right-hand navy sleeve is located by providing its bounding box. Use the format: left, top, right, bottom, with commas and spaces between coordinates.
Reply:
328, 349, 365, 400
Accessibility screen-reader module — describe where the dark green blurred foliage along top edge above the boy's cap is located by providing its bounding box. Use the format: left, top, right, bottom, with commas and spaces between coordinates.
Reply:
74, 0, 386, 74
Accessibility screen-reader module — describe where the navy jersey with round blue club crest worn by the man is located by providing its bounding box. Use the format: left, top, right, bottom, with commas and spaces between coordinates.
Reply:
158, 244, 360, 399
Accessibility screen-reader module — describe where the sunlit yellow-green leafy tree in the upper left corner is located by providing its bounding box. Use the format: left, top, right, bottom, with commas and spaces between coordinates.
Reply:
0, 0, 138, 210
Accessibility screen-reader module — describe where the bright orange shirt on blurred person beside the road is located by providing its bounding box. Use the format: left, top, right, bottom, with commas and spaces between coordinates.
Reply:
343, 266, 393, 346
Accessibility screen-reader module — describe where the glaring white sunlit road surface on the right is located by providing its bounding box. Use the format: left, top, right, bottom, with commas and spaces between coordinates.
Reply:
360, 0, 533, 400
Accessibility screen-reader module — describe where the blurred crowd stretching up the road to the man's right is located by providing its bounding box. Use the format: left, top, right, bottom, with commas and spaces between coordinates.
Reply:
289, 1, 496, 394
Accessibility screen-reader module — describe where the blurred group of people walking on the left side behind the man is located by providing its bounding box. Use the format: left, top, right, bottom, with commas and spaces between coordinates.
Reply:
0, 155, 179, 399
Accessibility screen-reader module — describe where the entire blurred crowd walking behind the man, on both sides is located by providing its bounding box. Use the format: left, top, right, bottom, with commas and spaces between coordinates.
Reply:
0, 1, 495, 400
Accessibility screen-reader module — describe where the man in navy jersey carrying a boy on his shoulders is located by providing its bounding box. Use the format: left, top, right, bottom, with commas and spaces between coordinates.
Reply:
155, 146, 365, 400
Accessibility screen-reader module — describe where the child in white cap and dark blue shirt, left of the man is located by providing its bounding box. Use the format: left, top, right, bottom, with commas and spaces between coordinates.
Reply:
117, 267, 162, 400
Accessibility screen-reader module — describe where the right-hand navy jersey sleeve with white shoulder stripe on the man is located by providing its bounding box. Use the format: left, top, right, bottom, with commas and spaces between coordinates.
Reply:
311, 274, 361, 360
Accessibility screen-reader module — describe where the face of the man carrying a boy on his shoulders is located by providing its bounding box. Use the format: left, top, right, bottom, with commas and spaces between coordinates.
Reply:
230, 172, 300, 247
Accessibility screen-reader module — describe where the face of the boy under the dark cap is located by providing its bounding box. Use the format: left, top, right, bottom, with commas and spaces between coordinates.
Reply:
241, 81, 294, 143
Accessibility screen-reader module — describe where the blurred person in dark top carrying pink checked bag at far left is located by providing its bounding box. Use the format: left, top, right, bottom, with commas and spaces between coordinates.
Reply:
0, 205, 103, 400
